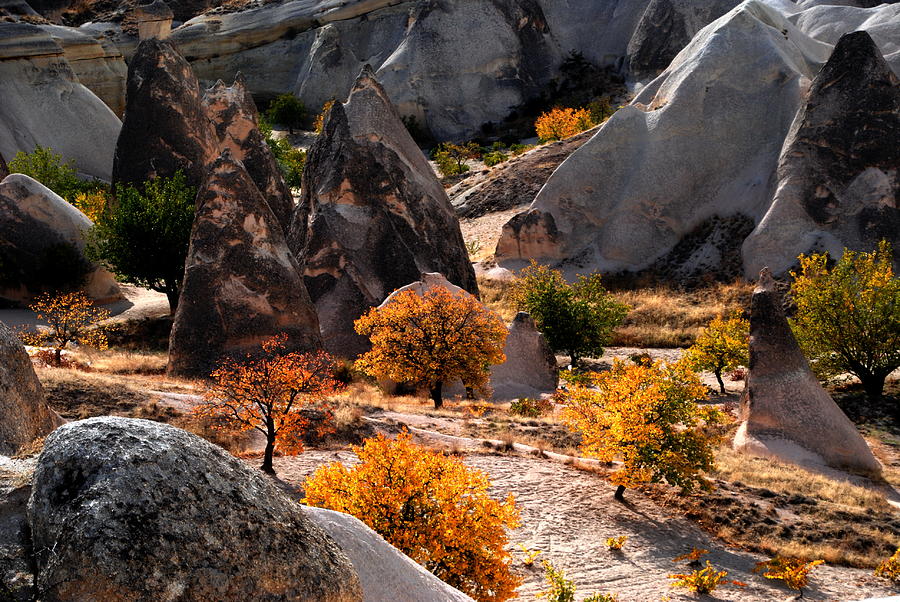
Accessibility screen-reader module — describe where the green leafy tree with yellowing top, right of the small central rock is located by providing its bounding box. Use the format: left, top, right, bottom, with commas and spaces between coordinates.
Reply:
513, 260, 629, 366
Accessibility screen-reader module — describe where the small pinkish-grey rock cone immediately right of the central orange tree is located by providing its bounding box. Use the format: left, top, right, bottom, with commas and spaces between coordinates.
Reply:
491, 312, 559, 399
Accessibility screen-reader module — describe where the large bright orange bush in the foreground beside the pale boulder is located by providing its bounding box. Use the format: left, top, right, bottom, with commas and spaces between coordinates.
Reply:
304, 432, 521, 602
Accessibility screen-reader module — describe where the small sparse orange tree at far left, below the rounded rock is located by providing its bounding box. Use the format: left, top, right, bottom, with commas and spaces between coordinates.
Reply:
21, 292, 109, 366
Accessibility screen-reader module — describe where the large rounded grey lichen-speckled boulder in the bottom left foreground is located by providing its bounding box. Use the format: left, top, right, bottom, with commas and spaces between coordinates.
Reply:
28, 417, 362, 602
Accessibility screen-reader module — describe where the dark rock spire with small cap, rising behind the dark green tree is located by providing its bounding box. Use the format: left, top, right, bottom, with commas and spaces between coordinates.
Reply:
113, 38, 218, 188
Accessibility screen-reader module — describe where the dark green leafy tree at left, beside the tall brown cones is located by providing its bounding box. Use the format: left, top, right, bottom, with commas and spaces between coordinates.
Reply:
87, 172, 197, 314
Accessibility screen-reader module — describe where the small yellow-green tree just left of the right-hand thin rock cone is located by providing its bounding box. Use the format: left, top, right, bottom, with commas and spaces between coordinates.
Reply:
687, 313, 750, 395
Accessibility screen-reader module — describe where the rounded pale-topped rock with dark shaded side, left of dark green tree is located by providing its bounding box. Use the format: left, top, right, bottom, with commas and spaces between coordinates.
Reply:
0, 174, 122, 303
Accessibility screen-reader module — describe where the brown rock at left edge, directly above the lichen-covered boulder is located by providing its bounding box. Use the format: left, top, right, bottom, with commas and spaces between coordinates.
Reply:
0, 322, 62, 455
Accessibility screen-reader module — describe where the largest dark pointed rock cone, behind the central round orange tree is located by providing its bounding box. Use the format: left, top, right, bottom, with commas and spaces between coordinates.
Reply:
289, 70, 478, 357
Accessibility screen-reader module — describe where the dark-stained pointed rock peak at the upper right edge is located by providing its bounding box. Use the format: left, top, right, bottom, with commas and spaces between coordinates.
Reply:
744, 31, 900, 274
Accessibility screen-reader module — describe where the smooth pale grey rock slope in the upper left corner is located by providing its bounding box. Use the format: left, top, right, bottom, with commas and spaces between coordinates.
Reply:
0, 23, 121, 180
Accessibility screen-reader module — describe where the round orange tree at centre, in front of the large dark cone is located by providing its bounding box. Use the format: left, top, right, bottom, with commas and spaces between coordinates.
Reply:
355, 287, 508, 408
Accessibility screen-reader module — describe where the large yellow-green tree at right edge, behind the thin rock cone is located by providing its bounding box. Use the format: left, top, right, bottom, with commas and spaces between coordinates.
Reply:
791, 241, 900, 400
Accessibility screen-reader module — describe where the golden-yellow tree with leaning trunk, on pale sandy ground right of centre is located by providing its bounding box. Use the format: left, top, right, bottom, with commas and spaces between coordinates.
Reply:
558, 361, 721, 500
